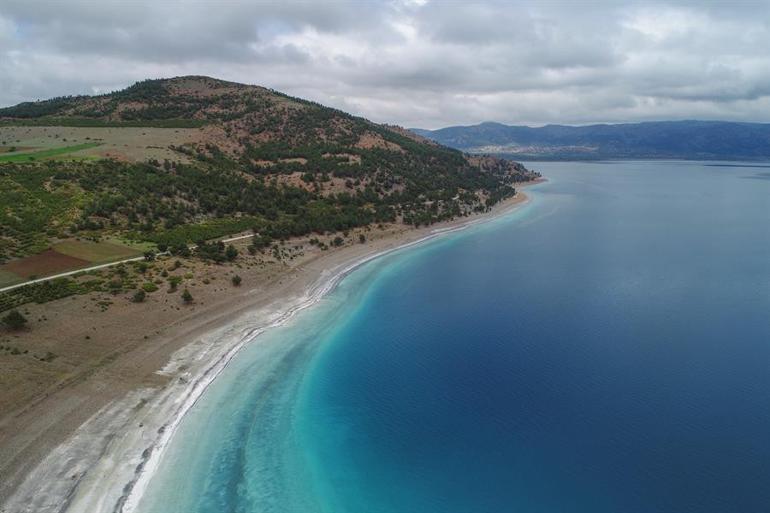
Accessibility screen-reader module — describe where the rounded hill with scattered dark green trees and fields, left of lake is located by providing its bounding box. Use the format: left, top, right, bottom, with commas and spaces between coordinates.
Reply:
0, 76, 536, 261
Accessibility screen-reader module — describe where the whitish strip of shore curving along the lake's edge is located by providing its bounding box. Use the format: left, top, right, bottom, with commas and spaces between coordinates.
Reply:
0, 184, 544, 513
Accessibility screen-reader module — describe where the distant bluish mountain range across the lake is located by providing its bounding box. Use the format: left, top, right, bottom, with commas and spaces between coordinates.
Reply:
412, 121, 770, 160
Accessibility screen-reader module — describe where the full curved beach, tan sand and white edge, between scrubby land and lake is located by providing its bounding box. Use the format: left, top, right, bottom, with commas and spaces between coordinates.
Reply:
0, 180, 545, 513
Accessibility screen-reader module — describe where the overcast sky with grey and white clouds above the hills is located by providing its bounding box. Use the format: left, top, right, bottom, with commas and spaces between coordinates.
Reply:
0, 0, 770, 128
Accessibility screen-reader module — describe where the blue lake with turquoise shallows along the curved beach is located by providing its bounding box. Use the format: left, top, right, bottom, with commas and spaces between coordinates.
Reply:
135, 162, 770, 513
